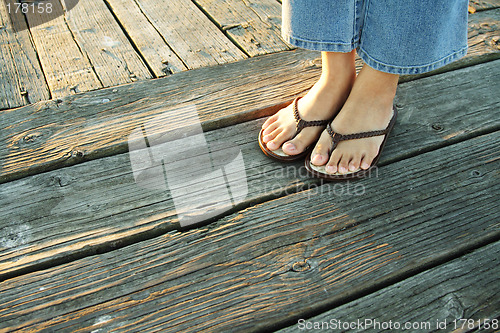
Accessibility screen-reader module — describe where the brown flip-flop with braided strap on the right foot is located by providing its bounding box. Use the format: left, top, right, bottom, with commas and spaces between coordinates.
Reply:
305, 107, 397, 181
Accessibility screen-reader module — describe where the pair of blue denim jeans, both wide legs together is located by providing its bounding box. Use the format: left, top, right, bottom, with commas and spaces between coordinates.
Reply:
282, 0, 468, 74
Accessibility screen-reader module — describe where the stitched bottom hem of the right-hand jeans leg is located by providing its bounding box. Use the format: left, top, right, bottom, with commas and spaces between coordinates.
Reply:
357, 46, 467, 75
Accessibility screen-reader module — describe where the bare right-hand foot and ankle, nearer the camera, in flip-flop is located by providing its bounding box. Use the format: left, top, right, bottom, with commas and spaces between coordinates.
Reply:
311, 65, 399, 174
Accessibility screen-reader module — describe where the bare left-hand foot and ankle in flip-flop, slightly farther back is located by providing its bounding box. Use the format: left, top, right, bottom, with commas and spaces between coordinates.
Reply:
262, 52, 356, 155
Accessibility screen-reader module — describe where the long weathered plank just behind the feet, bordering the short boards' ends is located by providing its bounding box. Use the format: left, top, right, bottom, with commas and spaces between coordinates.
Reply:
0, 3, 500, 183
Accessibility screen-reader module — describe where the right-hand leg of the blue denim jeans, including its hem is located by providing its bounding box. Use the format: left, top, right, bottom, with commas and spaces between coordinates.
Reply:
357, 0, 468, 74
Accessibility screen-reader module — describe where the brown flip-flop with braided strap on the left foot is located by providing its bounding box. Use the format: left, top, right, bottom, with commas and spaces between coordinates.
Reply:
259, 97, 330, 162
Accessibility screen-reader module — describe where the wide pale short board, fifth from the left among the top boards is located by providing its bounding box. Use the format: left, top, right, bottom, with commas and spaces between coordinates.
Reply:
131, 0, 246, 69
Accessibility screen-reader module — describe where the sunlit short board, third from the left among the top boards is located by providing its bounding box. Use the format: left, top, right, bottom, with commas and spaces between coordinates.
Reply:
59, 0, 151, 87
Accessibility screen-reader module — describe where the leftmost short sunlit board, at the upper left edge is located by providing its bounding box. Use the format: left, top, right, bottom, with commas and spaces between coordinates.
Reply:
0, 4, 50, 109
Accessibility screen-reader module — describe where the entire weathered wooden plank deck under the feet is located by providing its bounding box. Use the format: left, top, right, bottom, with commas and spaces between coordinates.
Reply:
0, 0, 500, 332
